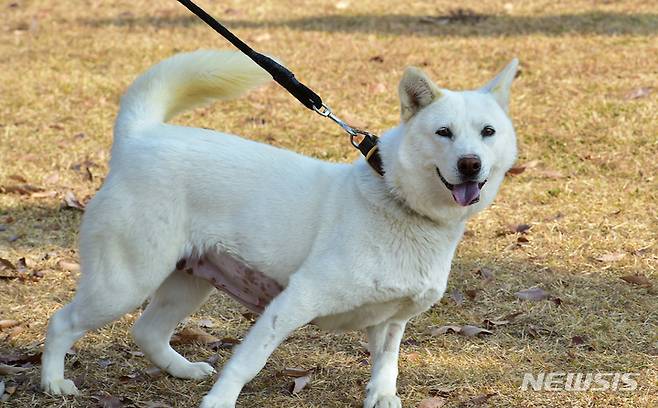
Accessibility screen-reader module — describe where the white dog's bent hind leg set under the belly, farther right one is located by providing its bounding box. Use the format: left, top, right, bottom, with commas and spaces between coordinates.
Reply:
133, 271, 214, 379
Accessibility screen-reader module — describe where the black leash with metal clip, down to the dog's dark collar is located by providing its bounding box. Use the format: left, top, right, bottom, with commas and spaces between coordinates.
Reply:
178, 0, 384, 176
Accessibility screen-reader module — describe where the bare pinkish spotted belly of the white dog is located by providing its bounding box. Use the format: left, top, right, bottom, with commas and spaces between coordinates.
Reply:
176, 254, 283, 313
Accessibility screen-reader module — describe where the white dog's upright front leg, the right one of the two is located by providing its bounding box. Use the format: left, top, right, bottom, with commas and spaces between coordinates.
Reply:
363, 321, 407, 408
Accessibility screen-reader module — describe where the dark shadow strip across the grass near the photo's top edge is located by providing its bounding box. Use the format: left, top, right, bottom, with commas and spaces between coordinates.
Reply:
80, 11, 658, 37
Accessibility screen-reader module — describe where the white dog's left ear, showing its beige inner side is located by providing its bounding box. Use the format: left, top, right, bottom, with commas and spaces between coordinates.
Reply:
398, 67, 441, 122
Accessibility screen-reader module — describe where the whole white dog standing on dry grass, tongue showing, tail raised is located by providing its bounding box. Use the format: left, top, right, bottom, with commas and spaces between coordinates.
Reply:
41, 51, 517, 408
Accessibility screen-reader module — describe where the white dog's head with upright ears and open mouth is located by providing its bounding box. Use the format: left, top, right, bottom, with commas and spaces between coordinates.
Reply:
382, 59, 518, 222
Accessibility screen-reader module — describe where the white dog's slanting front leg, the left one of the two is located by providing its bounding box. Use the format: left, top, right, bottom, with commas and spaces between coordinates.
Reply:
201, 282, 317, 408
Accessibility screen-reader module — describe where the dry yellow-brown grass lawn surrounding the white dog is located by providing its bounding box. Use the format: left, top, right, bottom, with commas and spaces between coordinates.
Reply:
0, 0, 658, 407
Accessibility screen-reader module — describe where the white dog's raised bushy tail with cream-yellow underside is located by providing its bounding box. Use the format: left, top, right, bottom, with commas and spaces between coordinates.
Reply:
115, 50, 272, 136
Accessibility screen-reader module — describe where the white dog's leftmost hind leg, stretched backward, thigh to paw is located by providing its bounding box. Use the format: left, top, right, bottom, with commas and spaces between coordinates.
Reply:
41, 241, 175, 394
